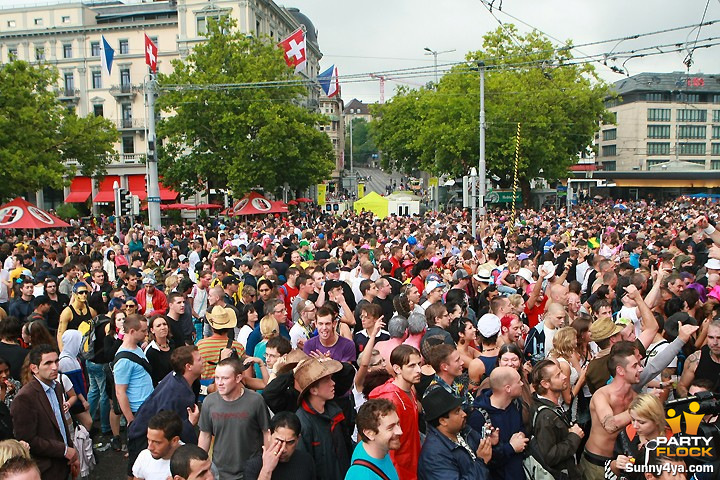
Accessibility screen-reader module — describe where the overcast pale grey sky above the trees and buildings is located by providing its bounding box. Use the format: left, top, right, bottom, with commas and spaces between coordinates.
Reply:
282, 0, 720, 103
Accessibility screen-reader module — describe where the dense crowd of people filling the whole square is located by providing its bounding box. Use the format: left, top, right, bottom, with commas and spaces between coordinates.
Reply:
0, 198, 720, 480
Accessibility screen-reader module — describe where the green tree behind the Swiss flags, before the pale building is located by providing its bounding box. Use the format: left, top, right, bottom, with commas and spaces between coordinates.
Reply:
158, 18, 335, 195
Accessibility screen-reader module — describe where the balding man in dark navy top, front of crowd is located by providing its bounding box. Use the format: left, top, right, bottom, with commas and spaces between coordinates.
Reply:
468, 367, 530, 480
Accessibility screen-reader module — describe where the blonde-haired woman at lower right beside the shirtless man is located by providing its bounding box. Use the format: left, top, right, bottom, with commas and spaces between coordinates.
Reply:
609, 393, 672, 479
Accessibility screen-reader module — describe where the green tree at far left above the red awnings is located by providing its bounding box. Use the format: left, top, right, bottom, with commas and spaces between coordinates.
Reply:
0, 61, 118, 198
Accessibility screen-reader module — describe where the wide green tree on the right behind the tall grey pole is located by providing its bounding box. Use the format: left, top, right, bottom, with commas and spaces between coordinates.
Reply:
373, 25, 610, 201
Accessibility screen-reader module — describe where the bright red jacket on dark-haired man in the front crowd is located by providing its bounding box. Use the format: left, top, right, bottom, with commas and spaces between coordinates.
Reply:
368, 378, 420, 480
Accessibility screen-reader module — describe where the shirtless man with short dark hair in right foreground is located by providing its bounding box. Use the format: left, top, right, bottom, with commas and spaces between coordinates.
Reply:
580, 341, 642, 480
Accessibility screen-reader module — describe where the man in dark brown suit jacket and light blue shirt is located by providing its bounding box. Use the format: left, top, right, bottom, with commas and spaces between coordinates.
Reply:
10, 345, 80, 480
